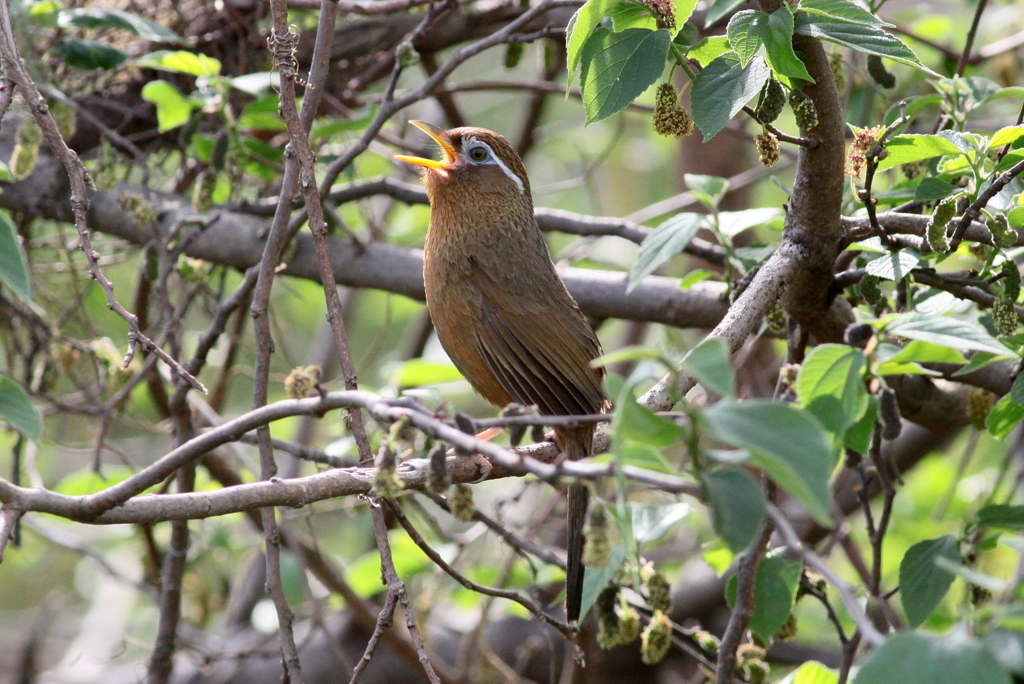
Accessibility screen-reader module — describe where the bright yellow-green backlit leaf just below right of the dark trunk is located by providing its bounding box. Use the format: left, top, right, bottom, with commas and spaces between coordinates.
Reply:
797, 344, 867, 435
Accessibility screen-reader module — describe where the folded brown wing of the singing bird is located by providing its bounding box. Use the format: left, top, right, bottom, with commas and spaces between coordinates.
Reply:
473, 271, 604, 416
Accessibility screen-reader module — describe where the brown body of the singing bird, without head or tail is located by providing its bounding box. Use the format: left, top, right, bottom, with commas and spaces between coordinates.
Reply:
424, 197, 604, 415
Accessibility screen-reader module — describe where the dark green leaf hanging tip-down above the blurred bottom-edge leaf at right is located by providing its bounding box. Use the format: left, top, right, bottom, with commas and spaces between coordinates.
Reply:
899, 535, 961, 627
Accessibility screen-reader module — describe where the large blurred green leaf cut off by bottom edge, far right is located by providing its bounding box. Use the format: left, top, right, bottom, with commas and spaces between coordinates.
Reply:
855, 630, 1011, 684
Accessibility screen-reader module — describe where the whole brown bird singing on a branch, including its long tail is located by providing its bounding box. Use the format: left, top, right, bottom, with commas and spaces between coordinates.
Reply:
395, 121, 605, 622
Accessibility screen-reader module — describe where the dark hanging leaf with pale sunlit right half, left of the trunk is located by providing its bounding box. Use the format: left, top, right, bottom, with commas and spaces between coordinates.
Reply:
690, 52, 771, 140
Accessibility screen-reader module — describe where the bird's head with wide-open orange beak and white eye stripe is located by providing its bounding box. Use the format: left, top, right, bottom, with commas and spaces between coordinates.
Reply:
395, 121, 532, 201
